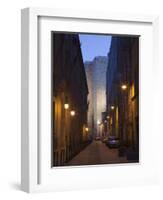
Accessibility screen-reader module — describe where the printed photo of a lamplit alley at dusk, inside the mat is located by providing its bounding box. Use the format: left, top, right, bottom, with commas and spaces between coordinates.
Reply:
51, 32, 139, 167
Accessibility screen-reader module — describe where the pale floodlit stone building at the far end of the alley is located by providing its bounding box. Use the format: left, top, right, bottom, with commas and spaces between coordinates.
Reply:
85, 56, 108, 137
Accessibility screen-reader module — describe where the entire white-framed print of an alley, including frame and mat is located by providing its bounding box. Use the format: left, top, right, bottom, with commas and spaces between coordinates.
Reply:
21, 8, 159, 192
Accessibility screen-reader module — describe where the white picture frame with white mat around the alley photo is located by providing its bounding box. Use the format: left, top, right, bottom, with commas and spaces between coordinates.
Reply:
21, 8, 159, 192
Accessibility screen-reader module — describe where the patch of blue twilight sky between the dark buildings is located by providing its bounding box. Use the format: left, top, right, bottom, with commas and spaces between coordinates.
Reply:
79, 34, 111, 62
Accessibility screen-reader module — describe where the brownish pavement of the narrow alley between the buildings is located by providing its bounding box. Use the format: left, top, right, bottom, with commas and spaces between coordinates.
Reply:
66, 141, 128, 165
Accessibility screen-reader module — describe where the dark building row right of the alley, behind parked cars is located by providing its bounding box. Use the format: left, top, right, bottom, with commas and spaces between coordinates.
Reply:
106, 36, 139, 159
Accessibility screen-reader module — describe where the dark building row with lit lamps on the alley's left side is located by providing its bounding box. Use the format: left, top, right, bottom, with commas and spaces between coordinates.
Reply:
52, 33, 88, 166
